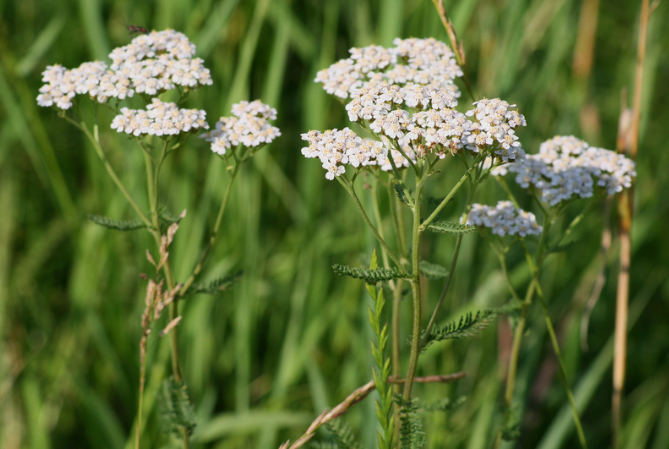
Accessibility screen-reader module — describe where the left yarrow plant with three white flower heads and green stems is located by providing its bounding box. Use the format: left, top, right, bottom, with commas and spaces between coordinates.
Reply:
37, 30, 281, 448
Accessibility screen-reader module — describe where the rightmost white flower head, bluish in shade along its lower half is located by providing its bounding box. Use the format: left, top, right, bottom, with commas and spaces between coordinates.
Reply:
494, 136, 636, 206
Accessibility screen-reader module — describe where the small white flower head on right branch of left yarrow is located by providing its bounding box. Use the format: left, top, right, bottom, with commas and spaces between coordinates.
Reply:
201, 100, 281, 155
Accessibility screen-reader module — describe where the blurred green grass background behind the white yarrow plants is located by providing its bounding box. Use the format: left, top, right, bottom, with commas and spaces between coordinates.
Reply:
0, 0, 669, 449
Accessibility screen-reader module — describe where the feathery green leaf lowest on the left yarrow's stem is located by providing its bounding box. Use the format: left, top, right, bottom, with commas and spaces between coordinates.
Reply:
160, 377, 196, 437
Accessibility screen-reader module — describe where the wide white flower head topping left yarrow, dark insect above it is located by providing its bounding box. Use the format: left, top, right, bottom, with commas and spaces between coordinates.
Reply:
37, 30, 212, 110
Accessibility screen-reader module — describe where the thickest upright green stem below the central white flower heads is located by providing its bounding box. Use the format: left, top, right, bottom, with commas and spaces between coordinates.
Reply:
402, 177, 425, 401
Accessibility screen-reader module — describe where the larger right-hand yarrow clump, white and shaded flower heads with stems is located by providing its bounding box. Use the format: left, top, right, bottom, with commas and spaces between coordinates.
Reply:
282, 38, 635, 448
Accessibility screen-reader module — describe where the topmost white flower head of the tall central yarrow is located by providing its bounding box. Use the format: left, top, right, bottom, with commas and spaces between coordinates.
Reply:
316, 38, 463, 99
